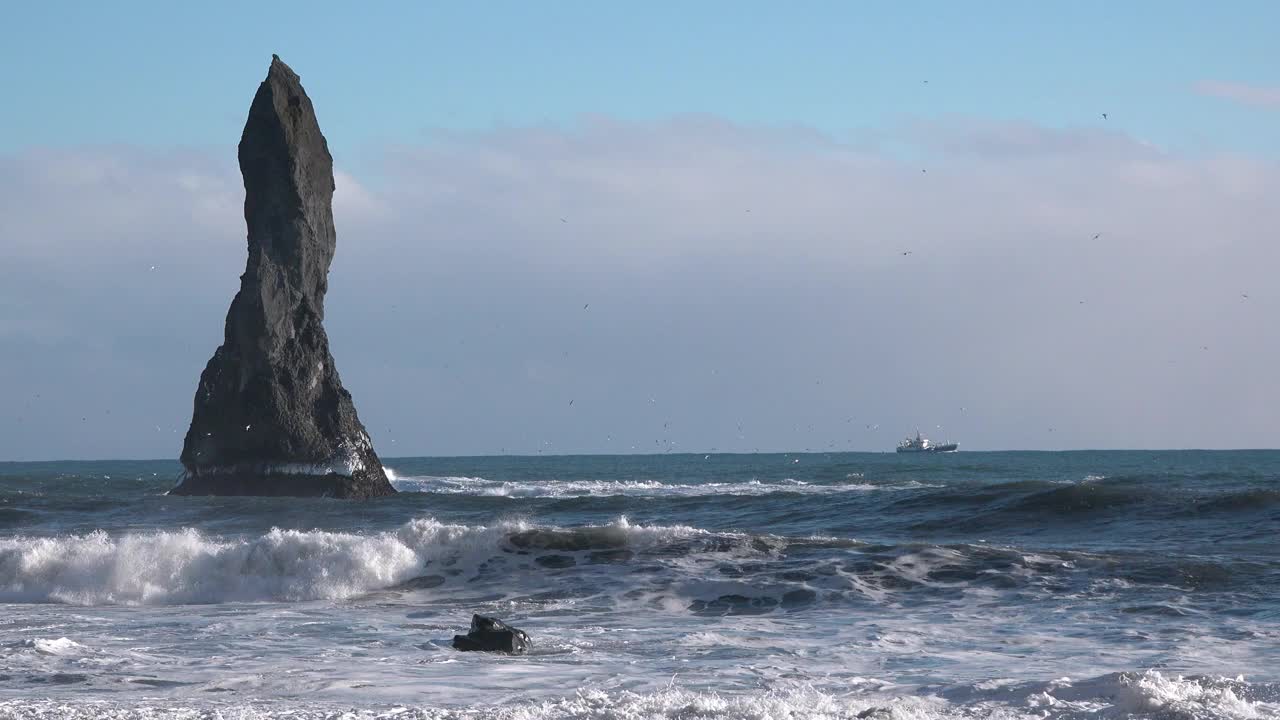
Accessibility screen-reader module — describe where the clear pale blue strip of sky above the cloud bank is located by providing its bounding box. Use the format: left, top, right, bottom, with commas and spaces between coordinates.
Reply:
0, 0, 1280, 156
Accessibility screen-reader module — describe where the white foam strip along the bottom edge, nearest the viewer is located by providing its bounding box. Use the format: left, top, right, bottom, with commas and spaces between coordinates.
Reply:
0, 671, 1280, 720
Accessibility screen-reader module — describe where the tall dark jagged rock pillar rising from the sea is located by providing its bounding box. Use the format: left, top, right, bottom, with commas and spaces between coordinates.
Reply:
172, 55, 396, 498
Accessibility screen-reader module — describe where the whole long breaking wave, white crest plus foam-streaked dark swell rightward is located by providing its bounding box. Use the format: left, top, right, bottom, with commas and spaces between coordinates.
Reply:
0, 518, 1259, 607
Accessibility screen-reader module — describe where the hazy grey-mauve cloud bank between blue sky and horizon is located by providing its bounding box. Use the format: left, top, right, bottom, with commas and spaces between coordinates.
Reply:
0, 117, 1280, 459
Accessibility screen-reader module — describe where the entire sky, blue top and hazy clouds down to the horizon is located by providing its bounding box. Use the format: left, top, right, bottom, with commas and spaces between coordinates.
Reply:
0, 1, 1280, 460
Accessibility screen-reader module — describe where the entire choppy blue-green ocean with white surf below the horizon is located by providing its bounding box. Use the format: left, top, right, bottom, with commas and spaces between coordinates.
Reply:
0, 451, 1280, 720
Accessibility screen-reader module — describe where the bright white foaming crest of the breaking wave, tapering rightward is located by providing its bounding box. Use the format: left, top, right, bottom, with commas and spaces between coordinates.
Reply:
0, 518, 793, 605
